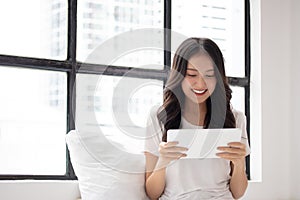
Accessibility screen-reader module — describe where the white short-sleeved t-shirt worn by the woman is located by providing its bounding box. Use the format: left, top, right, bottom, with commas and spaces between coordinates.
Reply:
145, 107, 250, 200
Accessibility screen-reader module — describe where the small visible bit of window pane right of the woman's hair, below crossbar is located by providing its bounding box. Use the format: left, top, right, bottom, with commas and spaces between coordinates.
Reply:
230, 86, 245, 112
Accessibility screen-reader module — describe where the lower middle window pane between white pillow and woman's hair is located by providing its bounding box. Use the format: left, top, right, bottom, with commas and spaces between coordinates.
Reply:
76, 74, 163, 153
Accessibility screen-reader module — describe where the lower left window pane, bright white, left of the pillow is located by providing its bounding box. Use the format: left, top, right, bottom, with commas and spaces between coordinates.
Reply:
0, 67, 67, 175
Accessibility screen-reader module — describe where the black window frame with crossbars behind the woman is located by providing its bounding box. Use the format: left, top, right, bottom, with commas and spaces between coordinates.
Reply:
0, 0, 251, 180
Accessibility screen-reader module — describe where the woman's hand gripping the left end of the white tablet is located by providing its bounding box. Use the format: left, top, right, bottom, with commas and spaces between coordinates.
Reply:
158, 141, 188, 168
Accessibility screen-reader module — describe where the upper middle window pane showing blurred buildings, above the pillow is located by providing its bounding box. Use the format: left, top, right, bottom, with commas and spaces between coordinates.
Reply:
77, 0, 164, 69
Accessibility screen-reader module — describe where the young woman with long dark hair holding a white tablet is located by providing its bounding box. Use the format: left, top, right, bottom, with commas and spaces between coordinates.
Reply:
145, 38, 250, 200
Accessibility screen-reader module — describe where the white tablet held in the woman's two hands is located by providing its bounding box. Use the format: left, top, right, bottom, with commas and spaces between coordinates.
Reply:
167, 128, 242, 159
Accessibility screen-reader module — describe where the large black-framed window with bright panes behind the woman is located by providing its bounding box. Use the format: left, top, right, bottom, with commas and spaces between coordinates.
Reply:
0, 0, 250, 179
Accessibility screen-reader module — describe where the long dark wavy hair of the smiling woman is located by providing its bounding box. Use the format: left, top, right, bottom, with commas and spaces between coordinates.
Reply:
157, 38, 236, 142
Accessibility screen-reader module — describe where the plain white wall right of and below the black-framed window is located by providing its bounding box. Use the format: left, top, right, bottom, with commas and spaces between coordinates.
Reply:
0, 0, 300, 200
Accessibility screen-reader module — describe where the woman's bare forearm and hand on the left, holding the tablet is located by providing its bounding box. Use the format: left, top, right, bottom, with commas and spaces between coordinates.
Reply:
145, 142, 187, 199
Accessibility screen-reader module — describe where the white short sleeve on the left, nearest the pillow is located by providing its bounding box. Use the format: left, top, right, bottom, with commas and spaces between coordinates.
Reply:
145, 106, 162, 156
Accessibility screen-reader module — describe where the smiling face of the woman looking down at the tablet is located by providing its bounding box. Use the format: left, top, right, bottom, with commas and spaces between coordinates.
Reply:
181, 53, 217, 104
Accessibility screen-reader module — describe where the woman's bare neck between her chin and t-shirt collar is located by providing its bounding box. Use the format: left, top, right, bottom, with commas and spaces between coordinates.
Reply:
182, 98, 207, 126
